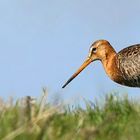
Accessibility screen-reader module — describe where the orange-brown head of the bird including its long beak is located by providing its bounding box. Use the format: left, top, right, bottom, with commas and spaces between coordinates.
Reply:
62, 40, 114, 88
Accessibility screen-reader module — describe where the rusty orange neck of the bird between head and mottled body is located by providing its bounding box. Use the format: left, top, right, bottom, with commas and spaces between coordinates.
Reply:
102, 50, 123, 84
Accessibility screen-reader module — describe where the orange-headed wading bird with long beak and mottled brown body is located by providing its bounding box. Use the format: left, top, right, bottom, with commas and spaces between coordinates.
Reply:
62, 39, 140, 88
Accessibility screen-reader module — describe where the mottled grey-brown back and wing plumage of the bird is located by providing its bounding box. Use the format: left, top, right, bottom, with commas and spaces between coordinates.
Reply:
117, 44, 140, 87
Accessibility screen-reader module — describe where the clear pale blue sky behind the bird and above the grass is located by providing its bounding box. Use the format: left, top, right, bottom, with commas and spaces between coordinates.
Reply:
0, 0, 140, 100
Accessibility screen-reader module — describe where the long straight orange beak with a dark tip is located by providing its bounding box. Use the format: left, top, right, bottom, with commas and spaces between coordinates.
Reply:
62, 58, 92, 88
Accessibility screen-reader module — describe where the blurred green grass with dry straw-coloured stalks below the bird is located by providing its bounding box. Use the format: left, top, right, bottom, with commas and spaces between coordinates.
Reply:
0, 93, 140, 140
